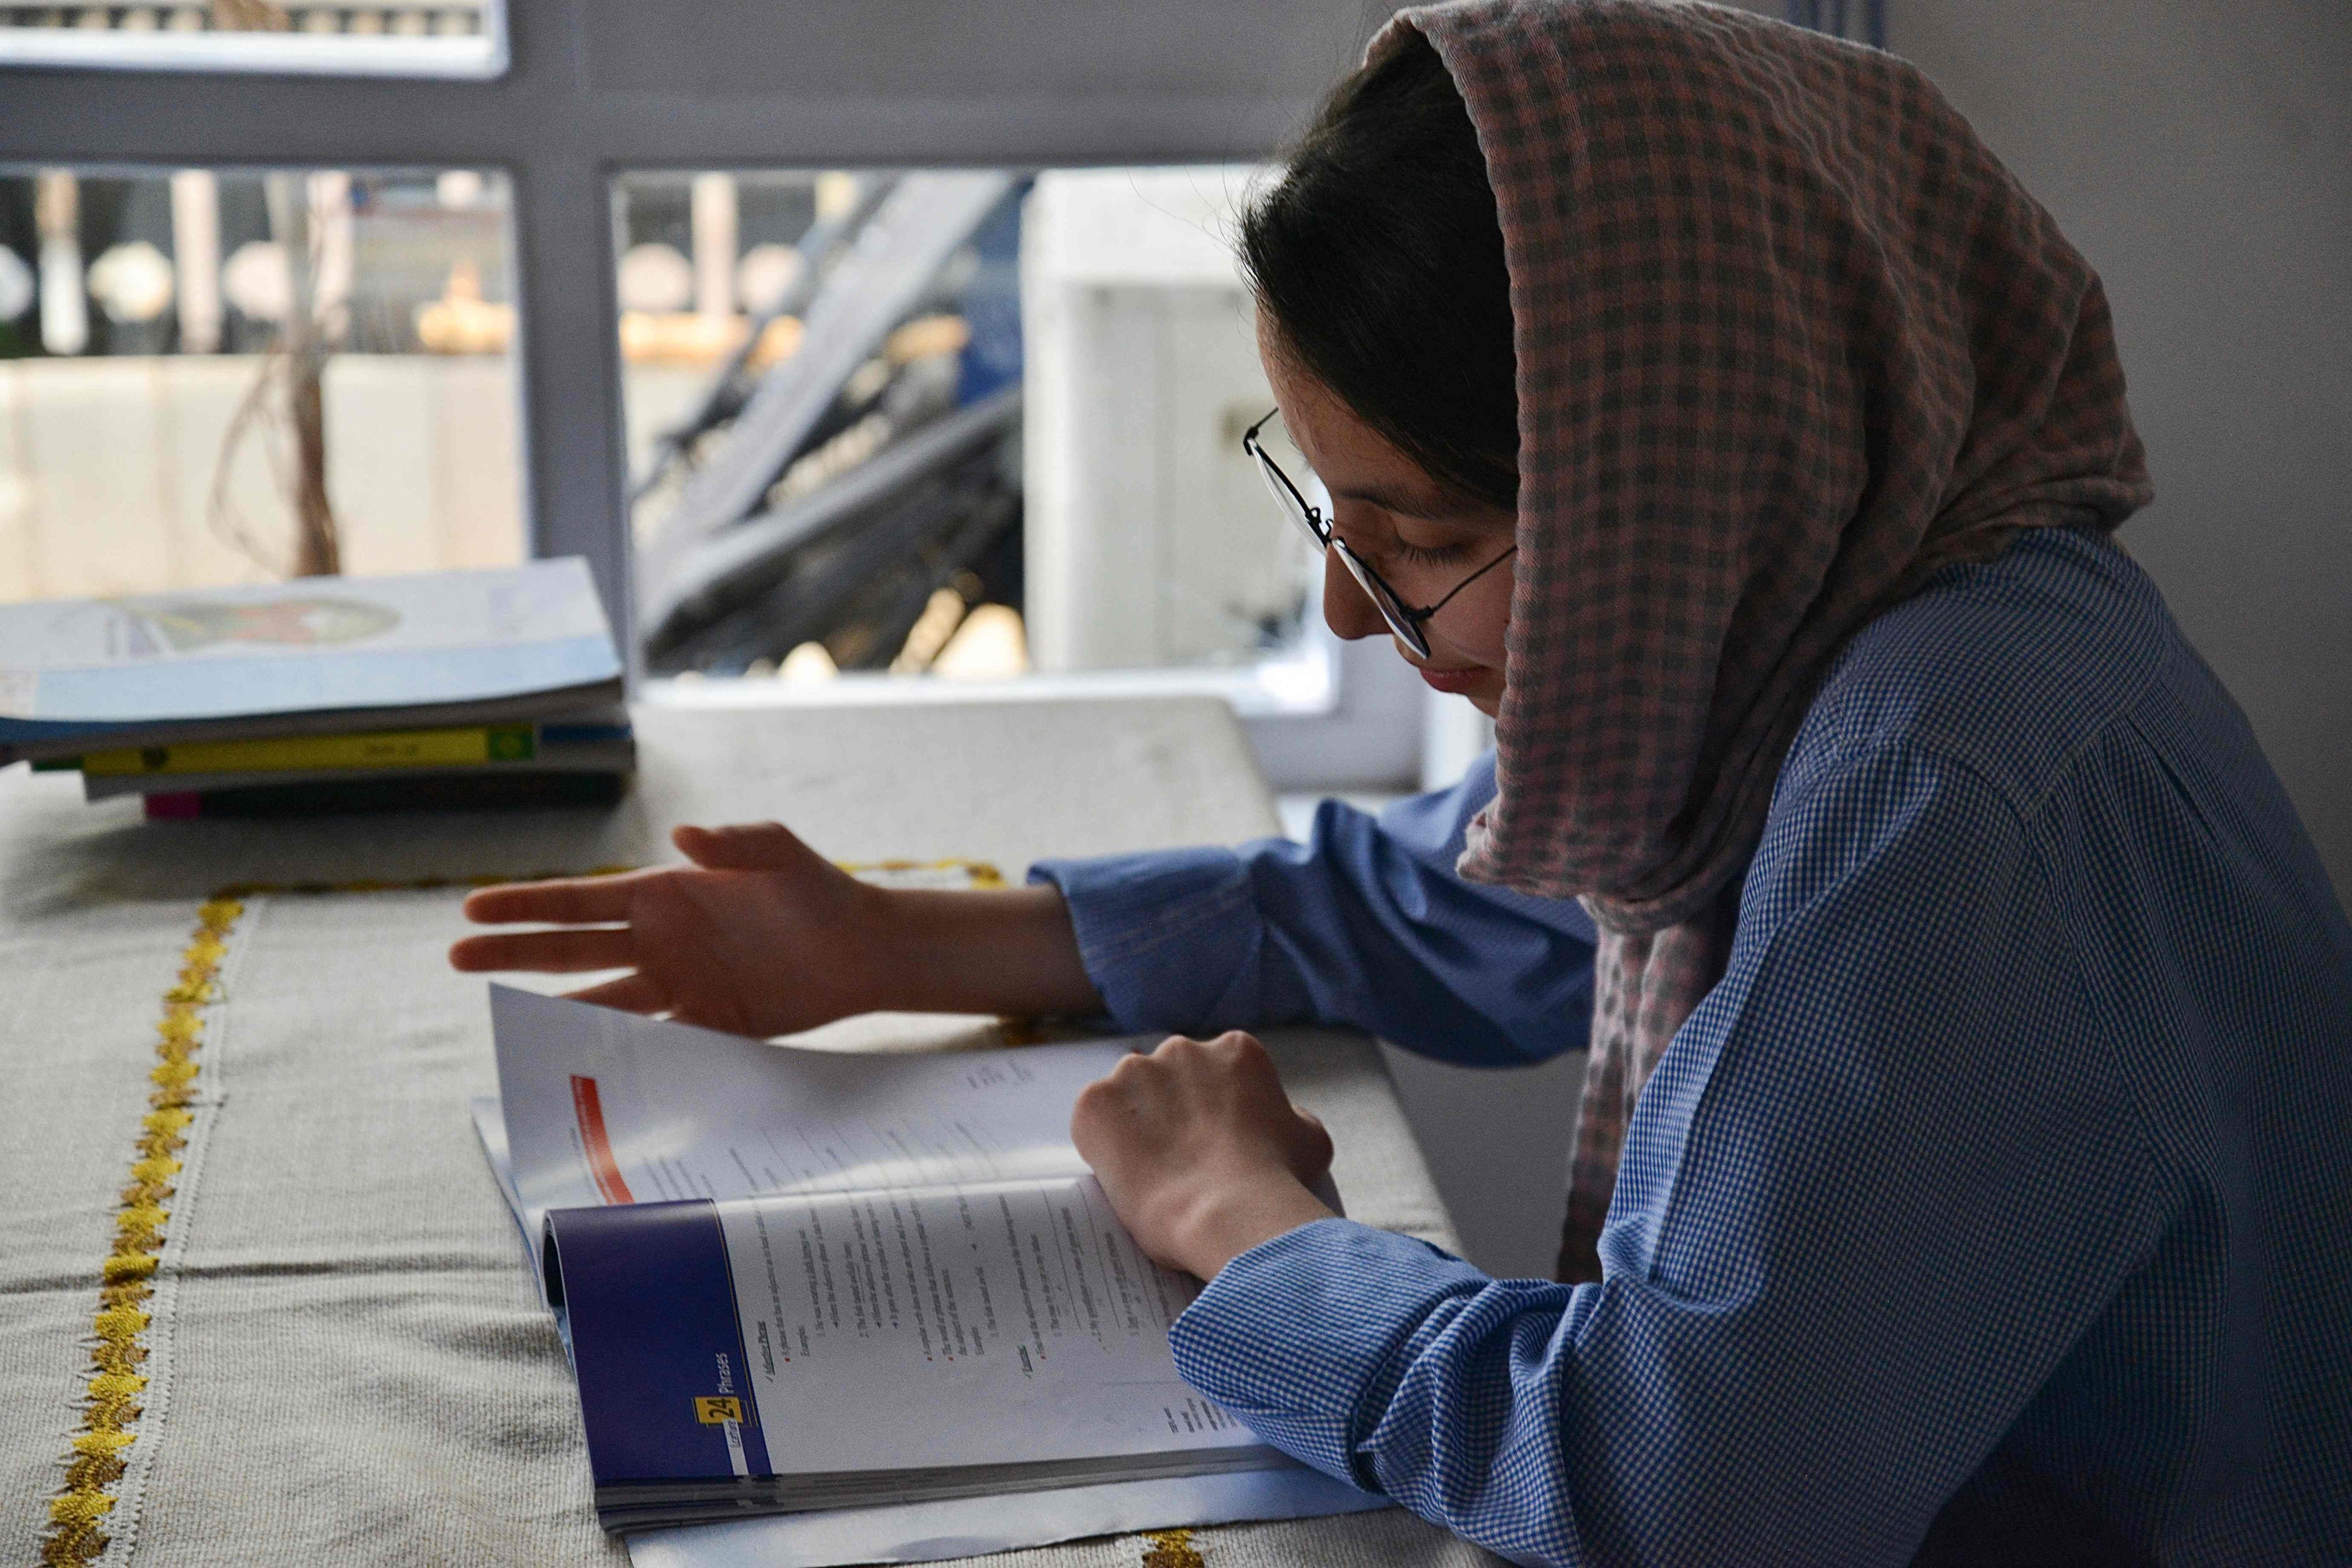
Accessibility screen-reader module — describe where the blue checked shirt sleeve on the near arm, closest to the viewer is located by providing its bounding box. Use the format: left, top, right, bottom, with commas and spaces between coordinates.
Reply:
1173, 752, 2176, 1566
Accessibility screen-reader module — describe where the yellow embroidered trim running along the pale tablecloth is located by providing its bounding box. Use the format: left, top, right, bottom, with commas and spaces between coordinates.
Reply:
40, 860, 1011, 1568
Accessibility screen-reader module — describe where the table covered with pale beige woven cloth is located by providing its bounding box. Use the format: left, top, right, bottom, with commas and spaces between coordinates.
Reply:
0, 698, 1493, 1568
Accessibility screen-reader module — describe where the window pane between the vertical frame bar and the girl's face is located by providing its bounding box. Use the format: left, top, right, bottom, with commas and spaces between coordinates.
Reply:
614, 167, 1322, 682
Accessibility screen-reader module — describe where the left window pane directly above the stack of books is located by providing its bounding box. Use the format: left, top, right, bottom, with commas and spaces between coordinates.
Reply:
0, 169, 524, 600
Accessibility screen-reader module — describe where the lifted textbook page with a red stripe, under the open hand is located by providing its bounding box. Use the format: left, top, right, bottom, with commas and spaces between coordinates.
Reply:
489, 985, 1157, 1237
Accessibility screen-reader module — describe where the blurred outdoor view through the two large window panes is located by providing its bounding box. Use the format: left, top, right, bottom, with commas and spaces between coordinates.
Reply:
0, 165, 1317, 682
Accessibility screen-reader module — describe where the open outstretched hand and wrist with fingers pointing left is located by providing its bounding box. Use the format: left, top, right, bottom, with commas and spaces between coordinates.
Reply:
449, 823, 1100, 1037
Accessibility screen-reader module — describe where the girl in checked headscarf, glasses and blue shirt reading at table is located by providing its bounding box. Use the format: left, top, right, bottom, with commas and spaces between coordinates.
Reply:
451, 0, 2352, 1563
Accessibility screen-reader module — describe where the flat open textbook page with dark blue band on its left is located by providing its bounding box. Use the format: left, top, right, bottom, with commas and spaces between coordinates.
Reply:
548, 1175, 1282, 1495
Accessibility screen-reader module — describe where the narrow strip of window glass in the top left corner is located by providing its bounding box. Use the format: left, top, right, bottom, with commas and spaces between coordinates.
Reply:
0, 0, 505, 78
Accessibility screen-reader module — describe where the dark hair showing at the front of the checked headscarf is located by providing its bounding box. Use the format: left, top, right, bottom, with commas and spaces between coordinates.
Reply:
1242, 33, 1519, 505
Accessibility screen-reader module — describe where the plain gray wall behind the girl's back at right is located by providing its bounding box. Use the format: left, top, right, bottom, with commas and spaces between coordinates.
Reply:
1888, 0, 2352, 901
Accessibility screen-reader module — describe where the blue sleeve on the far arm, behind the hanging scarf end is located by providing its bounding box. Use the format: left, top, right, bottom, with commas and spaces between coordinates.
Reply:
1030, 755, 1594, 1065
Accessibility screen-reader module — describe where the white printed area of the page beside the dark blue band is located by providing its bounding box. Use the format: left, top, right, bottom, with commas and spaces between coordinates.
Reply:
717, 1175, 1258, 1474
